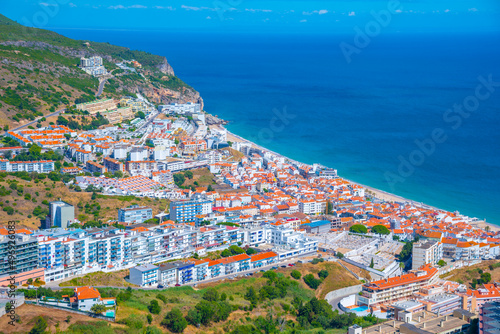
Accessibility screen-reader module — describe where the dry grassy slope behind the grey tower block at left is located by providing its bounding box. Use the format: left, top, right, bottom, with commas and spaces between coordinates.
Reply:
0, 175, 169, 229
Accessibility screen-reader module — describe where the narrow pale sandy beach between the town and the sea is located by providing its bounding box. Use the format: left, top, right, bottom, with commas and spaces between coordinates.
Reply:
213, 124, 500, 233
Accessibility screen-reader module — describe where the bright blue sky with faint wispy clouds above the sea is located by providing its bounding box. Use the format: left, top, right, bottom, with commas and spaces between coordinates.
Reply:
0, 0, 500, 33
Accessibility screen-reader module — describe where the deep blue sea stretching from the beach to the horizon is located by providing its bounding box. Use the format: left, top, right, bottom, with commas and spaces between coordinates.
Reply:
56, 29, 500, 225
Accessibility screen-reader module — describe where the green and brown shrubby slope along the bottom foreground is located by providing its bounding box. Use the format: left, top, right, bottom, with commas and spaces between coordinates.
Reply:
7, 262, 370, 334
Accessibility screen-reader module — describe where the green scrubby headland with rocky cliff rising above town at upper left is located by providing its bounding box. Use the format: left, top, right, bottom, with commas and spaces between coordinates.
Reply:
0, 14, 203, 129
